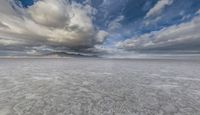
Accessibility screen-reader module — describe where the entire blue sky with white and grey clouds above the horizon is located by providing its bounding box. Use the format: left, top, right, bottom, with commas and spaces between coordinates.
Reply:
0, 0, 200, 56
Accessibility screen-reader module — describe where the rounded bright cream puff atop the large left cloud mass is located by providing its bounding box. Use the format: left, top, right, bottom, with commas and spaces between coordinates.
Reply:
28, 0, 68, 27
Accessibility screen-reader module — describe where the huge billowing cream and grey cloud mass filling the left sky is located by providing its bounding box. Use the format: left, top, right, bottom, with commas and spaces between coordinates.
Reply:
0, 0, 107, 54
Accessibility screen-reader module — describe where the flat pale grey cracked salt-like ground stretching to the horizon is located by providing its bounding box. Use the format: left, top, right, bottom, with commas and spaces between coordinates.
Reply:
0, 58, 200, 115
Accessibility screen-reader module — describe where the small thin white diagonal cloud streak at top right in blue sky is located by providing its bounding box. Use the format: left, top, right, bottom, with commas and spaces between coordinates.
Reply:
146, 0, 173, 18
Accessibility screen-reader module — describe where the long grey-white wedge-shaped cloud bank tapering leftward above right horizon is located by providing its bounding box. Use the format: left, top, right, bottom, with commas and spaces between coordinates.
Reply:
116, 10, 200, 51
